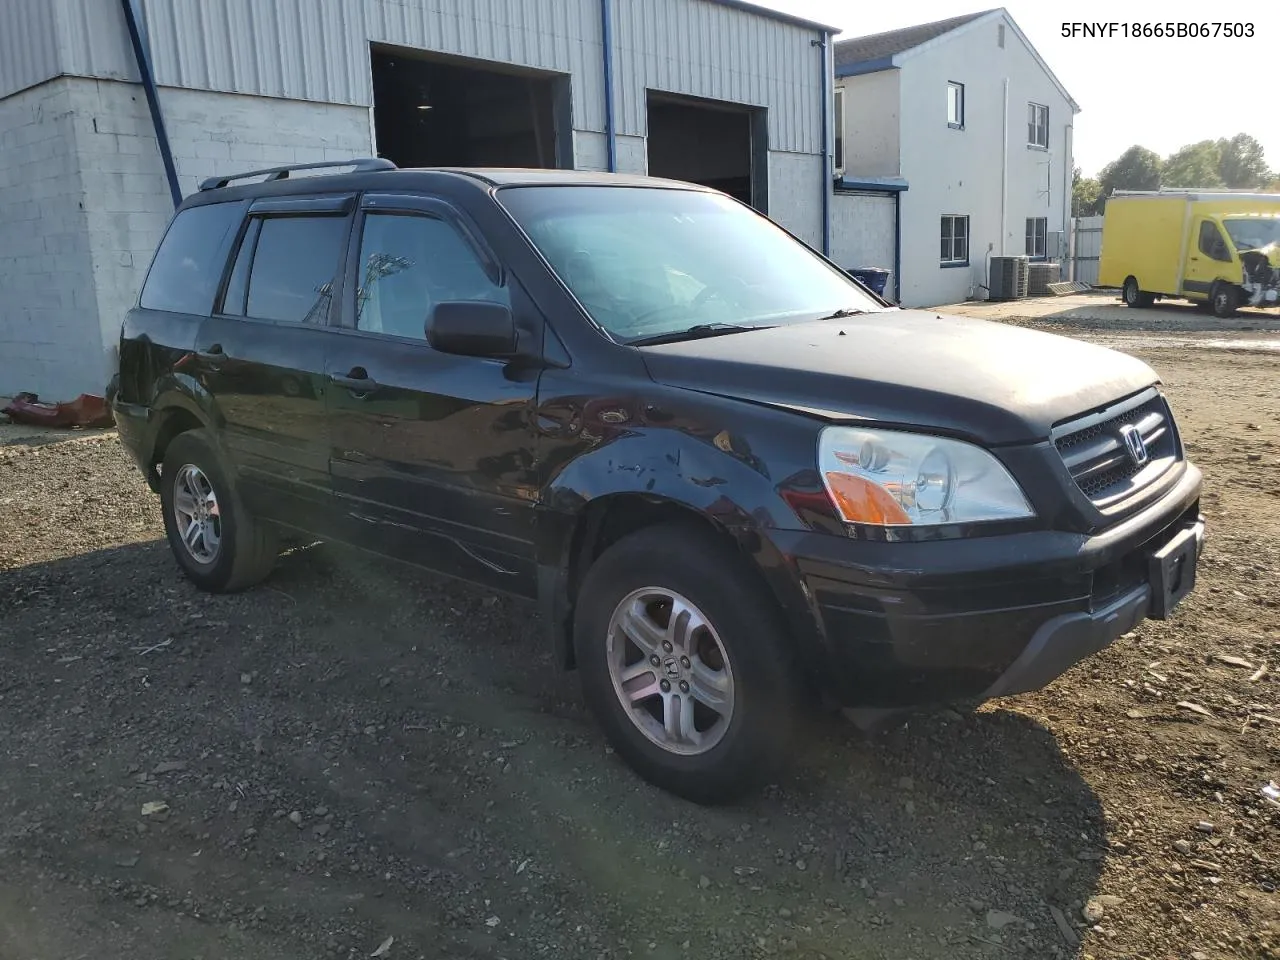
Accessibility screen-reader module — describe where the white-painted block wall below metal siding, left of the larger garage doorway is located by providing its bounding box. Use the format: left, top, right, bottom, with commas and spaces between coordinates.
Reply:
0, 77, 372, 399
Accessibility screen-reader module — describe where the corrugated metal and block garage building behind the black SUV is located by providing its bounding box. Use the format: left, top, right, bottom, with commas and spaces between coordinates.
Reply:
0, 0, 831, 399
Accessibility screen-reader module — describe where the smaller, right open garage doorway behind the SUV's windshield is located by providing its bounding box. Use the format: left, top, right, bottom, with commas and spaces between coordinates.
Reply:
648, 90, 768, 212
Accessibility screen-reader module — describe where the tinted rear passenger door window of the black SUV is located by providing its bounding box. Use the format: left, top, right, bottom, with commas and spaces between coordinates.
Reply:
240, 216, 348, 324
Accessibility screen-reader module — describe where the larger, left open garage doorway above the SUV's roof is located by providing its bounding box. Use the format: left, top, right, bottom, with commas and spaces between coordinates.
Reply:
371, 46, 573, 168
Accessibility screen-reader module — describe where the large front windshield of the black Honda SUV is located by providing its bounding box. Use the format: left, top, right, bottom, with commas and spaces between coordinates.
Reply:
498, 187, 886, 340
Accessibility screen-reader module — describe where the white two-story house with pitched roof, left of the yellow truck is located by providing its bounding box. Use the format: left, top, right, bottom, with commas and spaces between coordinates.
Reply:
832, 9, 1079, 306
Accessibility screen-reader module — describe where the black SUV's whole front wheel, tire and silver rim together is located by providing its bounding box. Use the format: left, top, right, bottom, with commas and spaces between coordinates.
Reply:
573, 524, 797, 804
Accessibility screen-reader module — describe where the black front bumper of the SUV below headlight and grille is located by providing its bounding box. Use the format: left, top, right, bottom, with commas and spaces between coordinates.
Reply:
773, 465, 1204, 708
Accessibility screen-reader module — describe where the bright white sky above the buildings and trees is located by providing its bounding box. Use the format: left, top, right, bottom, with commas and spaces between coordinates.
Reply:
754, 0, 1280, 175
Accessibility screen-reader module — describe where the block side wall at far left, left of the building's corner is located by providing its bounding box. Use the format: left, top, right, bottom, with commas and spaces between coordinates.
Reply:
0, 78, 101, 399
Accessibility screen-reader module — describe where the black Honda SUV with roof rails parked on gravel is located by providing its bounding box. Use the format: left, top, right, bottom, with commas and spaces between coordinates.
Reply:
111, 160, 1204, 803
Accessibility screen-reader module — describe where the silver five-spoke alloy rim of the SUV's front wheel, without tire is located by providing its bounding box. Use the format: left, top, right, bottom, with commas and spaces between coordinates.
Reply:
607, 586, 733, 756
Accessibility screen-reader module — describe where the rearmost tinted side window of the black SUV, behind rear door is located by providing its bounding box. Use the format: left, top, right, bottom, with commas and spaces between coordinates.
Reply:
138, 202, 246, 316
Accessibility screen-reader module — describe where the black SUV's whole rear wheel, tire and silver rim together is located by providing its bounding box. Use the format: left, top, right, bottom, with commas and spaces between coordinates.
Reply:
160, 430, 279, 593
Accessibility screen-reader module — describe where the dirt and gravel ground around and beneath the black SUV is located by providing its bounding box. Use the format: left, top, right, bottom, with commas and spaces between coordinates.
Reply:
0, 305, 1280, 960
